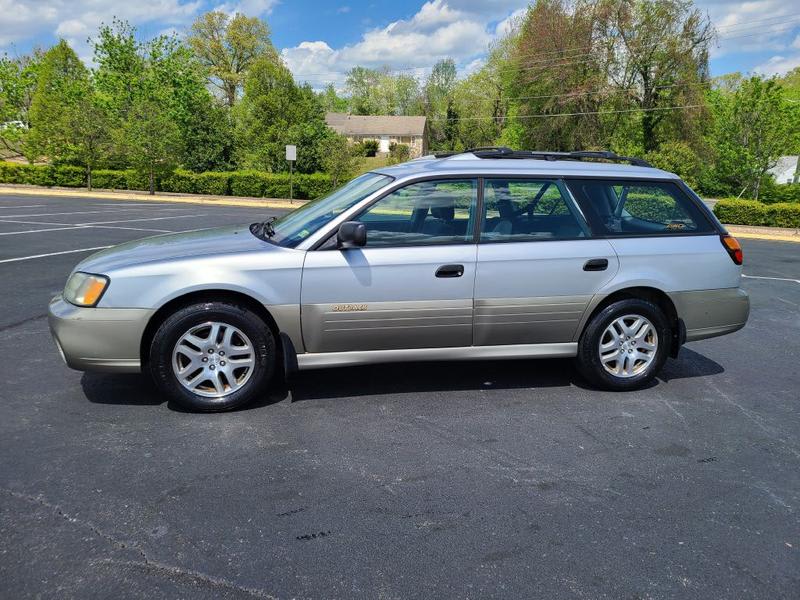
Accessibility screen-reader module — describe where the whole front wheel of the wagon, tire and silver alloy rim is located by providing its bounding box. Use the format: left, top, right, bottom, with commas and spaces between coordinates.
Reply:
149, 302, 275, 411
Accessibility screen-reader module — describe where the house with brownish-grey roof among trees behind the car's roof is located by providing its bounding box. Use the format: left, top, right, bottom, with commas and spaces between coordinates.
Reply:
325, 112, 428, 158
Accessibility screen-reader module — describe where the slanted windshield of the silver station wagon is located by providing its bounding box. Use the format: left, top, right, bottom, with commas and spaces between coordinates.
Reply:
262, 173, 393, 248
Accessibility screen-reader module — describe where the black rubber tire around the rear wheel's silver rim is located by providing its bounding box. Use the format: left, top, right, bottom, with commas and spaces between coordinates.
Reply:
576, 298, 672, 391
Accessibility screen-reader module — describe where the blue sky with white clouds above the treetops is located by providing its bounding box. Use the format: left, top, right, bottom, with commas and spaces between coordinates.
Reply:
0, 0, 800, 87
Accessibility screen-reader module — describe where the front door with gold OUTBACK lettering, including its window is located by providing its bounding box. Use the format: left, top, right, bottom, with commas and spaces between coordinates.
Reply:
301, 179, 478, 352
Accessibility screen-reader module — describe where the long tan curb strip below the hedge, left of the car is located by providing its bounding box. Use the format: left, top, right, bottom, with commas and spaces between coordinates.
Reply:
0, 184, 307, 210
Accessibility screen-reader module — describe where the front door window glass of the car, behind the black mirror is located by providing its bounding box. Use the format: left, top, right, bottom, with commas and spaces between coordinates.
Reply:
357, 179, 478, 248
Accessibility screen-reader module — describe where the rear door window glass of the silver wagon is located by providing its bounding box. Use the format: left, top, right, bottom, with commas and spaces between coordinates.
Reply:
481, 179, 587, 242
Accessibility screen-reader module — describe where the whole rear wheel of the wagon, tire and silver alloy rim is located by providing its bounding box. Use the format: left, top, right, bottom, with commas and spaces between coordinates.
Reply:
577, 298, 672, 391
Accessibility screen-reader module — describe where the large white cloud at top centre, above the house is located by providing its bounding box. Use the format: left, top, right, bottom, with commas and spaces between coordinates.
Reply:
282, 0, 527, 88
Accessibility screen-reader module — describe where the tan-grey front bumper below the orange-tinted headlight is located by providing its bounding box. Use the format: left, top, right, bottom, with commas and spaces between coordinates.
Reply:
48, 296, 155, 373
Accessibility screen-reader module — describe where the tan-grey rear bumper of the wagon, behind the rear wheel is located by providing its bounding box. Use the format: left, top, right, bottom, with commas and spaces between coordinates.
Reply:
669, 288, 750, 342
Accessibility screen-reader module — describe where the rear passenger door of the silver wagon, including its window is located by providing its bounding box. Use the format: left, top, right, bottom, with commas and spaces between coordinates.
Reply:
475, 178, 619, 346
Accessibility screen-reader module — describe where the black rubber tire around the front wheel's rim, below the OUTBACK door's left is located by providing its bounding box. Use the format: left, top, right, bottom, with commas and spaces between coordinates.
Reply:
148, 302, 277, 412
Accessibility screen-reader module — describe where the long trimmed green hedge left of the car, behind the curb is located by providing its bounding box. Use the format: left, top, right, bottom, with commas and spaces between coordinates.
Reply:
0, 162, 332, 200
